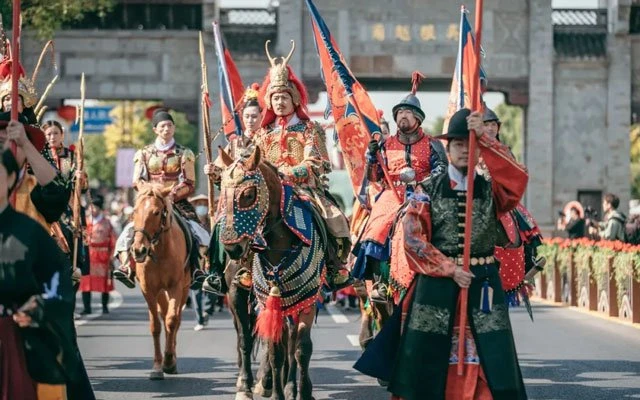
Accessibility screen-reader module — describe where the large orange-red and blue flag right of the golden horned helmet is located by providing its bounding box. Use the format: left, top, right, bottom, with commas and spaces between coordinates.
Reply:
305, 0, 380, 196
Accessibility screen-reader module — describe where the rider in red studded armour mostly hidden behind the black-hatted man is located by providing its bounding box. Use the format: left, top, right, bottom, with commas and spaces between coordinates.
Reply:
478, 106, 546, 308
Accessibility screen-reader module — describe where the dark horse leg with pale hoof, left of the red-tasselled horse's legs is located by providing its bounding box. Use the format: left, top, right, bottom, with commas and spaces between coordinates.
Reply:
227, 284, 253, 400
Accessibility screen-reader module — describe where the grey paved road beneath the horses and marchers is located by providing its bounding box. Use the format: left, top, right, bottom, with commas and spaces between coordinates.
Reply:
78, 286, 640, 400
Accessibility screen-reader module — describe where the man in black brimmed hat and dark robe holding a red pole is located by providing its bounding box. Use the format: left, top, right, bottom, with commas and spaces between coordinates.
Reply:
380, 109, 528, 400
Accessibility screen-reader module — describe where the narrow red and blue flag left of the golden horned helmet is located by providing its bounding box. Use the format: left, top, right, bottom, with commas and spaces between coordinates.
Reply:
213, 22, 244, 137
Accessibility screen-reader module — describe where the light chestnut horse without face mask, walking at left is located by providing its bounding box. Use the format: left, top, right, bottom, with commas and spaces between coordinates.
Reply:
131, 184, 191, 380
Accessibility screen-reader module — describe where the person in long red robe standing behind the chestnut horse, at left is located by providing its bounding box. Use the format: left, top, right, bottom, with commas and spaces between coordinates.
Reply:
80, 194, 116, 314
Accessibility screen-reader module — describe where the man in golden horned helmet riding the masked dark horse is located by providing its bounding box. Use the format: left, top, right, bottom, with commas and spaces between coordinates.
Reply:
254, 42, 351, 289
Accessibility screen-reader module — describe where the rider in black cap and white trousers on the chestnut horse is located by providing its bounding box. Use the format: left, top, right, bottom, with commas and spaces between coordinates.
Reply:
113, 109, 209, 289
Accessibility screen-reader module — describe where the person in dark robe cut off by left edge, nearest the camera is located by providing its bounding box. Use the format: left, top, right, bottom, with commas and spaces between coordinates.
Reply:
0, 148, 79, 400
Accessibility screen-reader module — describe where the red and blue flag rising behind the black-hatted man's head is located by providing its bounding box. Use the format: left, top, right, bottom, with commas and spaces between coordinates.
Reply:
442, 6, 486, 133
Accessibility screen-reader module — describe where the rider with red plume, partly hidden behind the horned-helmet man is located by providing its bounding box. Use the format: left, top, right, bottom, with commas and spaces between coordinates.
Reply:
204, 83, 262, 297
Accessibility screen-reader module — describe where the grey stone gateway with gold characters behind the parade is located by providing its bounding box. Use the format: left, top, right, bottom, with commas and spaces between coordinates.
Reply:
23, 0, 640, 228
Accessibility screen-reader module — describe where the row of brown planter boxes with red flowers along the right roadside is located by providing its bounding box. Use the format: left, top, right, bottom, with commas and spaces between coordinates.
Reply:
536, 238, 640, 324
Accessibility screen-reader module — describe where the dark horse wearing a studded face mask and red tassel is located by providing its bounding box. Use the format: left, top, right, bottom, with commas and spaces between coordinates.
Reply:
219, 147, 326, 400
